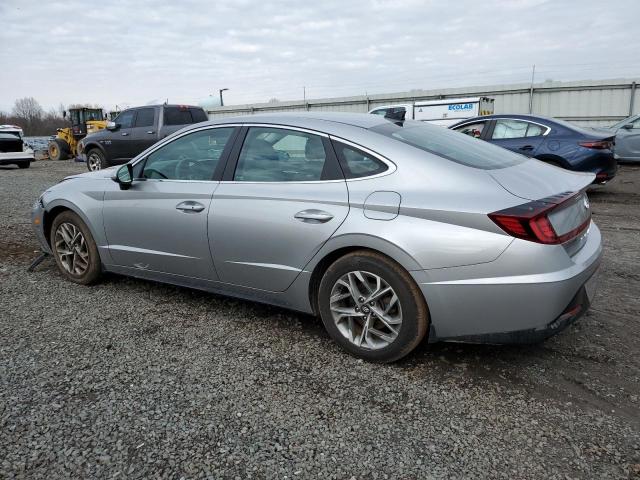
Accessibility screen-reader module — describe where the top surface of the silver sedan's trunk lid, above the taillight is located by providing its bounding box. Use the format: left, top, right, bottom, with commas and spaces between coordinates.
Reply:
487, 159, 595, 201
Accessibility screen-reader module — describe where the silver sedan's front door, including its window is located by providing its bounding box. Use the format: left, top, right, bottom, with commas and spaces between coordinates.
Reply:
104, 127, 234, 280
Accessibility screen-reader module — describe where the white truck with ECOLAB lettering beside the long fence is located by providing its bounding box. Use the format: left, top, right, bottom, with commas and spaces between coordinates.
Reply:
369, 97, 494, 127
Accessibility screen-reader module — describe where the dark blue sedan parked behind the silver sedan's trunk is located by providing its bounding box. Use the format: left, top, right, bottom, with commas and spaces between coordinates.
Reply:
449, 115, 618, 183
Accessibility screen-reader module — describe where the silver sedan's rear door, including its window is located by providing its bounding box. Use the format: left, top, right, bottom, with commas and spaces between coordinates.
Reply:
209, 127, 349, 292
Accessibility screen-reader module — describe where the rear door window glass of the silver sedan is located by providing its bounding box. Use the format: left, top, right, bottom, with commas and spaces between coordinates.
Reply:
234, 127, 327, 182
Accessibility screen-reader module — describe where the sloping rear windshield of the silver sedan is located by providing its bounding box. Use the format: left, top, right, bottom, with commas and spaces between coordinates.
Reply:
371, 121, 527, 170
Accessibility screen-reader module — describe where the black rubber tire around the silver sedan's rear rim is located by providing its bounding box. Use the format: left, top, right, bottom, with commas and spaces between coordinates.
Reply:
318, 250, 429, 363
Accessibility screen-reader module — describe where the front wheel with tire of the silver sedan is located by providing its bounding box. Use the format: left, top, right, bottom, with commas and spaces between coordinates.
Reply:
51, 211, 102, 285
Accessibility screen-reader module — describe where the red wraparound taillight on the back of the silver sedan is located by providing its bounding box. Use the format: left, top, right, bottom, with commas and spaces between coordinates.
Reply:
489, 193, 591, 245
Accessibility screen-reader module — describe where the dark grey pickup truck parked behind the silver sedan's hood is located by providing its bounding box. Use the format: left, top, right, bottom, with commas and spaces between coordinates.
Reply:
79, 104, 208, 171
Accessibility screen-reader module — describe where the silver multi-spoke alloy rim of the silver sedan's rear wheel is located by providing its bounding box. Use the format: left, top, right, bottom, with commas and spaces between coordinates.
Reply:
329, 270, 402, 350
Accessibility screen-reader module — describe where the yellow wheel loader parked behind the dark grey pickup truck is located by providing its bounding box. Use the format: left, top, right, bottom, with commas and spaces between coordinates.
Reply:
48, 107, 107, 160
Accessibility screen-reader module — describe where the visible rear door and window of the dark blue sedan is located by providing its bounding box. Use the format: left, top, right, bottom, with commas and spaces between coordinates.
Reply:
486, 118, 550, 157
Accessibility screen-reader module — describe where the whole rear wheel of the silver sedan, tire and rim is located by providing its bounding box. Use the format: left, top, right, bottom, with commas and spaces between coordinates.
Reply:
318, 250, 429, 363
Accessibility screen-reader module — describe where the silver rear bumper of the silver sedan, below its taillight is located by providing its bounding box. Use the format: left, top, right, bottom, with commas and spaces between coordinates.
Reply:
411, 223, 602, 343
